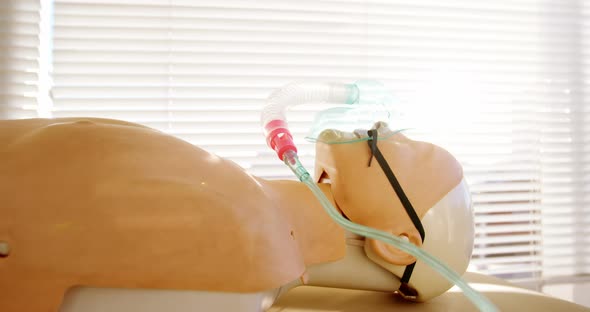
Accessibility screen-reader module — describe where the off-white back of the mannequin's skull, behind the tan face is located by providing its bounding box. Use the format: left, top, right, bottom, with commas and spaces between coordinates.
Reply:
365, 179, 475, 301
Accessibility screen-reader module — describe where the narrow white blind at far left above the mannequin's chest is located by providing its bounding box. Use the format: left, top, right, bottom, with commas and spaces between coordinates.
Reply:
0, 0, 40, 119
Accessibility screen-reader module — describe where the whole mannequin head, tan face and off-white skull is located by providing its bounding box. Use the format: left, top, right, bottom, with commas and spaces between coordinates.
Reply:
315, 123, 473, 301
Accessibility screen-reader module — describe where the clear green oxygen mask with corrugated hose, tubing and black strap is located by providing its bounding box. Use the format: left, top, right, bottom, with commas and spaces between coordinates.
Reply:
261, 80, 497, 311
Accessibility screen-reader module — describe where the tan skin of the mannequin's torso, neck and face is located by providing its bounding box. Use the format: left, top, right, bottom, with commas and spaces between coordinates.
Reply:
0, 118, 463, 312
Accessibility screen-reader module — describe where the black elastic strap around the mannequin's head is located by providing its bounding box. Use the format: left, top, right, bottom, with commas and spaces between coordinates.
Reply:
367, 129, 425, 295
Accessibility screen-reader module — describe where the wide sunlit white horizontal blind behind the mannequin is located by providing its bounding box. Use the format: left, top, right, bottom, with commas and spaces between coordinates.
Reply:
52, 0, 589, 290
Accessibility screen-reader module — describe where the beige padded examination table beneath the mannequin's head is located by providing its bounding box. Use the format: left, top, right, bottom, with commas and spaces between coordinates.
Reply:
270, 272, 590, 312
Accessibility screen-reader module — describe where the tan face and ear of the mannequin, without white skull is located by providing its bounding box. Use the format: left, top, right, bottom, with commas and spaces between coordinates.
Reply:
316, 123, 463, 265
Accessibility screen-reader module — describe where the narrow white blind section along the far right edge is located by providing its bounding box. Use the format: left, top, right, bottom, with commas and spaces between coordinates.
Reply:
536, 1, 590, 283
